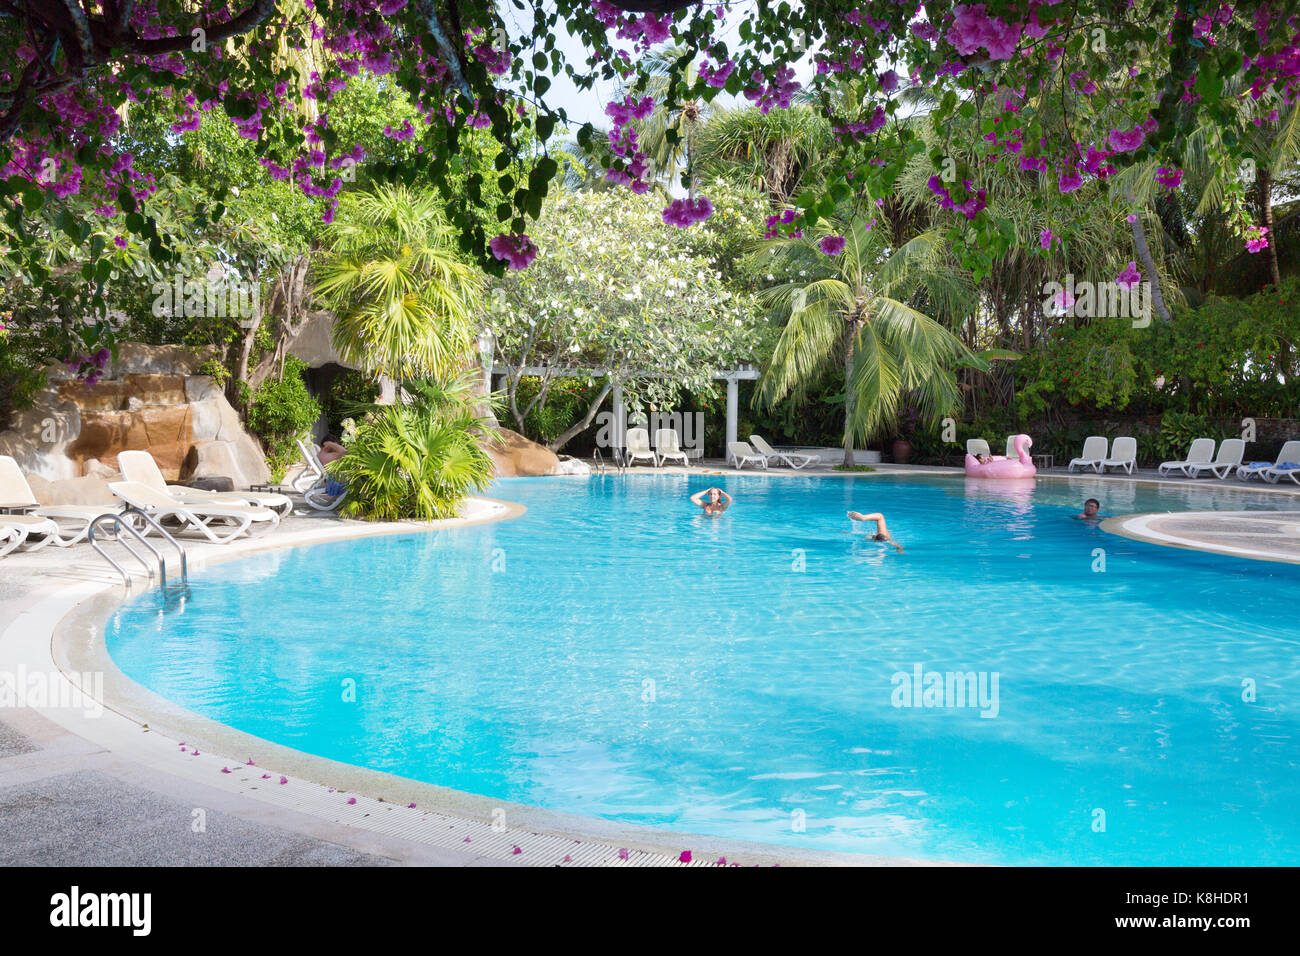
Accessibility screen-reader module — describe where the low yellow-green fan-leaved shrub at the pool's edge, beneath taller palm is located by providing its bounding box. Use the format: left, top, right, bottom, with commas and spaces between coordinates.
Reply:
329, 381, 493, 522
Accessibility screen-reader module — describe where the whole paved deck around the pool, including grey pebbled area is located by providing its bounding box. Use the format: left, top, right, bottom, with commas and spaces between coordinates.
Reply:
0, 462, 1300, 866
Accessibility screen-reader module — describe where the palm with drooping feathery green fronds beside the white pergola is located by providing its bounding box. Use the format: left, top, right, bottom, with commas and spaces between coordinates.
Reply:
754, 213, 983, 466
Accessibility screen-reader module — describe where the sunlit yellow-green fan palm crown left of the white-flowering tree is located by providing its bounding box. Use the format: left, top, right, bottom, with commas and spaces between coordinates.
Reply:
313, 186, 482, 380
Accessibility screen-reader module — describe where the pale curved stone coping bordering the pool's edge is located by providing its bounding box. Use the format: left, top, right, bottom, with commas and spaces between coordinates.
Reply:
12, 468, 1300, 866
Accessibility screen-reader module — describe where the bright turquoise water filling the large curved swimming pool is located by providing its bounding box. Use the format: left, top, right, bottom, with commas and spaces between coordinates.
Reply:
108, 473, 1300, 865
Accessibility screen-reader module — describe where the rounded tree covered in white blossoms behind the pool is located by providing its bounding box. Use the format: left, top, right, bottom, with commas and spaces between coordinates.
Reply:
490, 193, 762, 450
